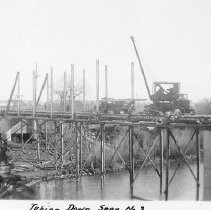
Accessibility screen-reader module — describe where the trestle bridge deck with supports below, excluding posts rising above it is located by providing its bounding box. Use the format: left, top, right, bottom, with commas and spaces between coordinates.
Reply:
0, 110, 211, 200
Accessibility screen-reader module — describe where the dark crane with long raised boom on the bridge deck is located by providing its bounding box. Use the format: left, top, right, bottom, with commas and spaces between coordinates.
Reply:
131, 36, 195, 114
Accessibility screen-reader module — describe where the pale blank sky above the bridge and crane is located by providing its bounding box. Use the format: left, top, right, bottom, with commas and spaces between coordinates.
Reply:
0, 0, 211, 101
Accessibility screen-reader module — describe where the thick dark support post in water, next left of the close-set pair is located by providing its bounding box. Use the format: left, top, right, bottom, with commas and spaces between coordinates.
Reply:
129, 125, 134, 199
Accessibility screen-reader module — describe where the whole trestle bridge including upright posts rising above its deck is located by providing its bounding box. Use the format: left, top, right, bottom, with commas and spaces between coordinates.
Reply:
0, 70, 211, 200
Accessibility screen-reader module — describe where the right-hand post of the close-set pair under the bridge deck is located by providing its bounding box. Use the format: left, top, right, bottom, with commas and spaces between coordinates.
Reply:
165, 128, 170, 201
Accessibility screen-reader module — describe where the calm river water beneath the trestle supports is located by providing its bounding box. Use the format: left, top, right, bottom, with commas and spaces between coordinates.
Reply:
31, 162, 203, 200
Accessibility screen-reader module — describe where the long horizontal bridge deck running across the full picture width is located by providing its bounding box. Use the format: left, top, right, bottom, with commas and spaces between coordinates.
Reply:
0, 110, 211, 127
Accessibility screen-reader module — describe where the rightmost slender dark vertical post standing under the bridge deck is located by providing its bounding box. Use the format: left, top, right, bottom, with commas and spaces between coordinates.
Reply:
196, 128, 200, 201
